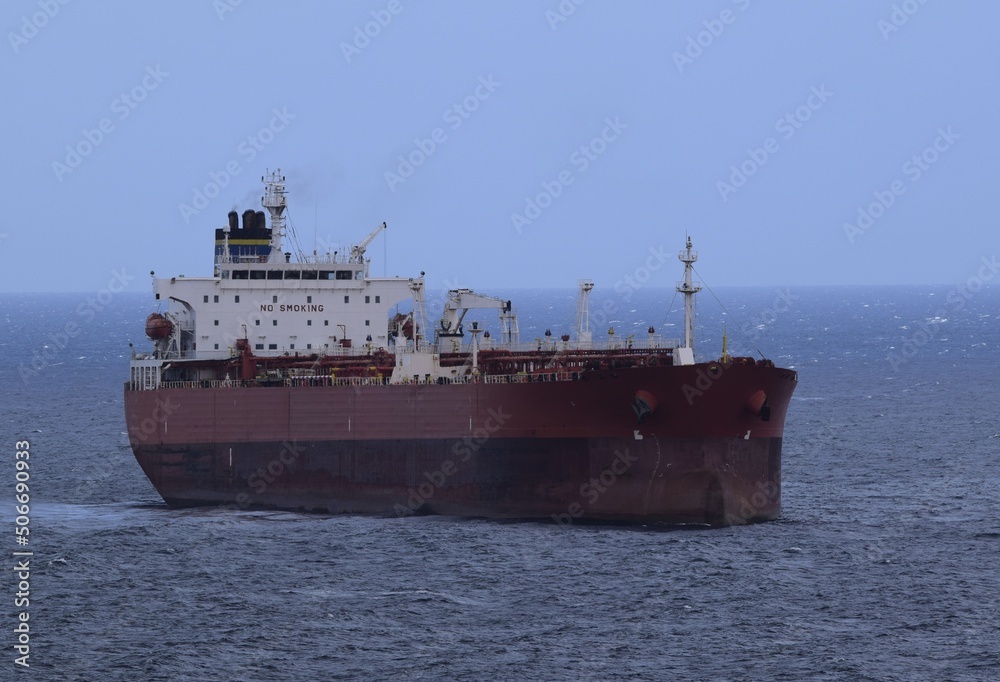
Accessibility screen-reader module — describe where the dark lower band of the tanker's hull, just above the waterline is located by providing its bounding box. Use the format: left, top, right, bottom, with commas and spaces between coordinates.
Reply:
134, 434, 781, 526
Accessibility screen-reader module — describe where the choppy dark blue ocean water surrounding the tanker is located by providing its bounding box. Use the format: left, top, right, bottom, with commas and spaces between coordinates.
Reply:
0, 286, 1000, 681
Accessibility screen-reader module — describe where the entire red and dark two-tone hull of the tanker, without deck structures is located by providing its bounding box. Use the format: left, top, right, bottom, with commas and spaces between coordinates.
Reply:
125, 363, 796, 525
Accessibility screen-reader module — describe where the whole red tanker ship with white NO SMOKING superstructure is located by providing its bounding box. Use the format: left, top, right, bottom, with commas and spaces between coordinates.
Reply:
124, 170, 797, 526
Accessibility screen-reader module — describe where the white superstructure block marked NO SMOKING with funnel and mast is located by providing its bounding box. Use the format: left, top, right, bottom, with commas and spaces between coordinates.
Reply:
153, 171, 424, 360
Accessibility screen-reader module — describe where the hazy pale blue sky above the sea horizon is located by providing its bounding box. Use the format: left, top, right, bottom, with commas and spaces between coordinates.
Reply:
0, 0, 1000, 291
